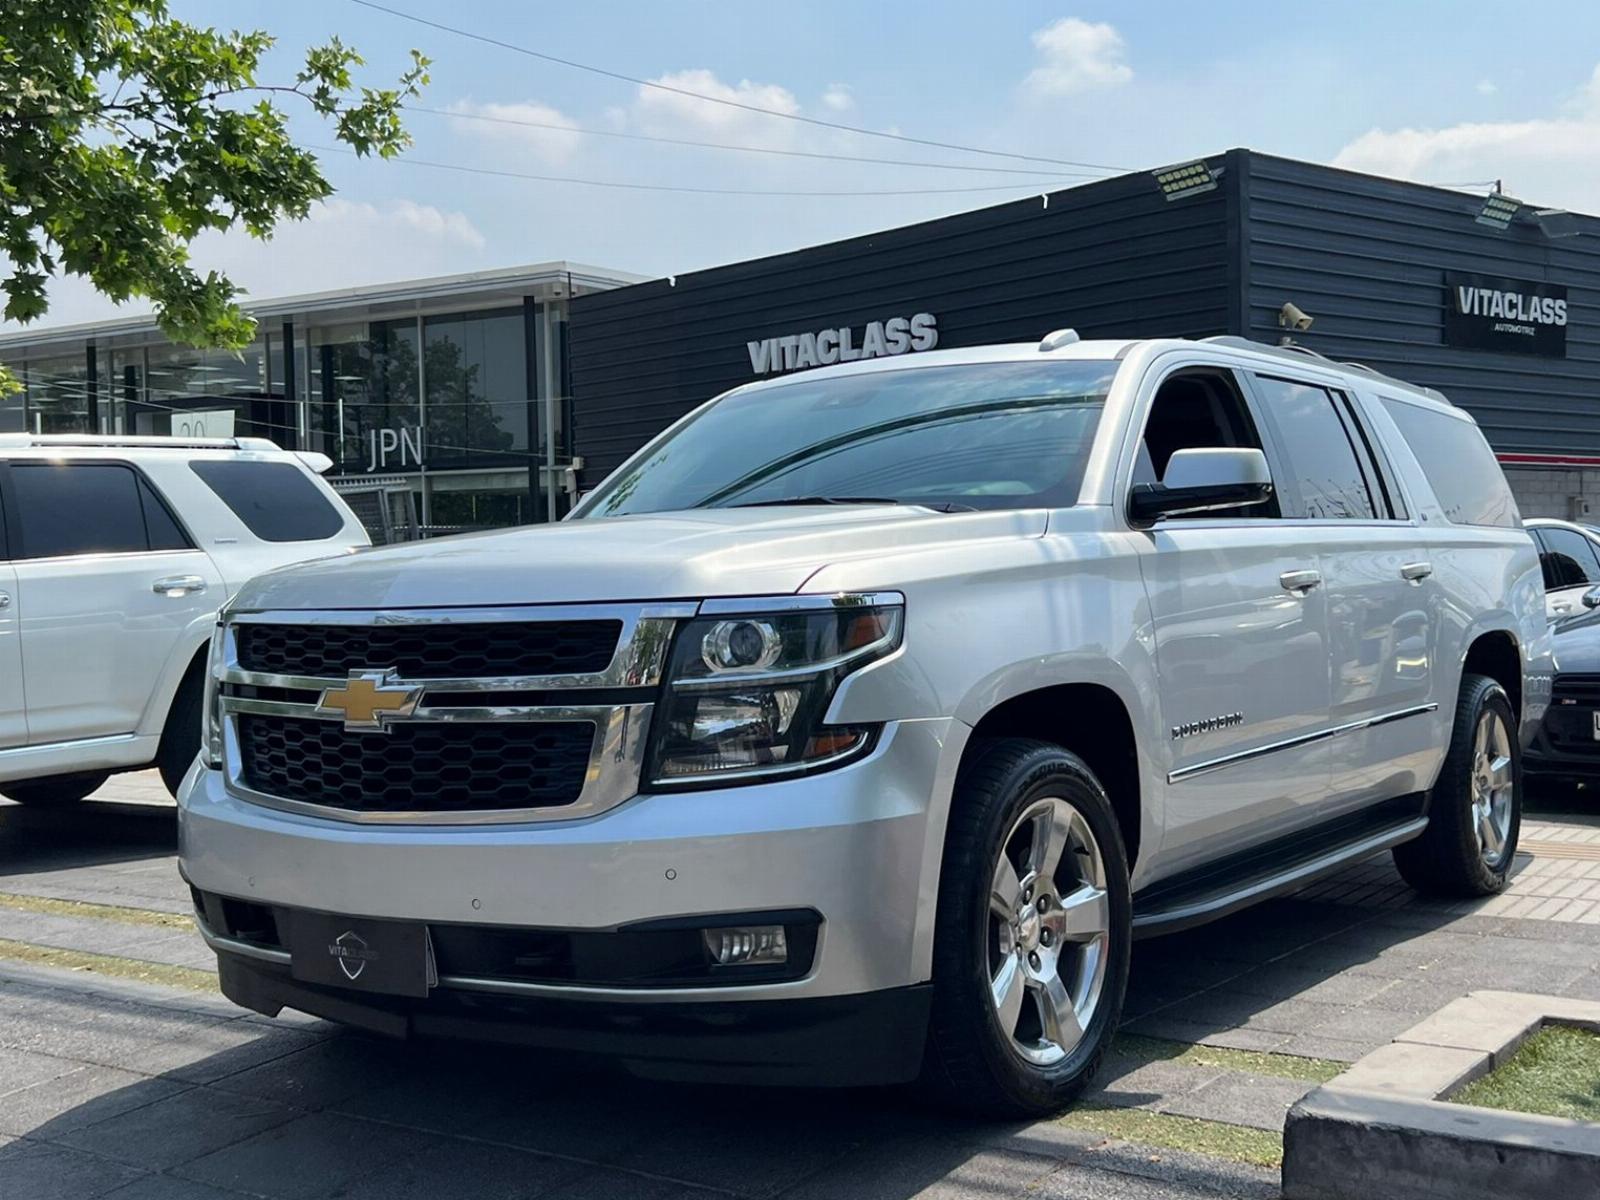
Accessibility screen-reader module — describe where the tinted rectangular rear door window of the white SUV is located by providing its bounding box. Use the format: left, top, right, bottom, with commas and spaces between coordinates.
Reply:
11, 462, 149, 558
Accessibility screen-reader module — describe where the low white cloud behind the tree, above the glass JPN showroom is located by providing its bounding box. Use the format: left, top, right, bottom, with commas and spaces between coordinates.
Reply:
0, 197, 486, 333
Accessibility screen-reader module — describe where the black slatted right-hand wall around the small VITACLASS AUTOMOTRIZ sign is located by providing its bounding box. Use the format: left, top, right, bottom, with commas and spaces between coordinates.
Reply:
1230, 152, 1600, 456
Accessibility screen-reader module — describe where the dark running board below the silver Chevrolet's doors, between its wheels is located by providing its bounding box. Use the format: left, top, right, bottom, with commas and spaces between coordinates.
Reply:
1133, 795, 1427, 938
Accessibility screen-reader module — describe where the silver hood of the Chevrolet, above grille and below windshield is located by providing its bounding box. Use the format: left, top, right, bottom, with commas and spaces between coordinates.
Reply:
234, 504, 1046, 608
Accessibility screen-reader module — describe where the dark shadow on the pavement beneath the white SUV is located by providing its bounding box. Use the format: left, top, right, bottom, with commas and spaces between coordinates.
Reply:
0, 800, 178, 875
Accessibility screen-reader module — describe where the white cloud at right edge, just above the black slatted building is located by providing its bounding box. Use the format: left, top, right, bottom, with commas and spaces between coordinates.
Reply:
1333, 67, 1600, 213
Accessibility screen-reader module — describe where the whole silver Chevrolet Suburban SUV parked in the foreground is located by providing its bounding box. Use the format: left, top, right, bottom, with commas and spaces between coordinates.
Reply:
181, 331, 1549, 1114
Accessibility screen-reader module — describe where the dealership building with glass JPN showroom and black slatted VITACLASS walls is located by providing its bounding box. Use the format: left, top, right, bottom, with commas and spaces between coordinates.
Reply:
0, 150, 1600, 536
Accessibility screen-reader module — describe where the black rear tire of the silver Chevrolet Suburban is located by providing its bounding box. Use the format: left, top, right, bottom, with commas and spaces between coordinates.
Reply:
1394, 675, 1523, 899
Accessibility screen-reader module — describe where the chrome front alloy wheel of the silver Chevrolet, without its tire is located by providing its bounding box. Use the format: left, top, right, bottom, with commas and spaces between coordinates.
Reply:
989, 797, 1110, 1066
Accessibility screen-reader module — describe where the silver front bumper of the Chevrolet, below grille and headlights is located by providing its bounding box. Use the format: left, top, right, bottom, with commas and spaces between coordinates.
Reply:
179, 720, 960, 1021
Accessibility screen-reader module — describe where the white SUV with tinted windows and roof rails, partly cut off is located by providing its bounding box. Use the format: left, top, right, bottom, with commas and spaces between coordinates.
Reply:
0, 434, 368, 803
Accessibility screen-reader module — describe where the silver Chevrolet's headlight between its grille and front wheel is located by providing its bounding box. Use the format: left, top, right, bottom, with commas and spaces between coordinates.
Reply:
650, 597, 904, 787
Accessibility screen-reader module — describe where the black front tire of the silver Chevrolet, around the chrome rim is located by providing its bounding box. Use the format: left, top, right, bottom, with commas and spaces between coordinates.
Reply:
922, 738, 1133, 1117
